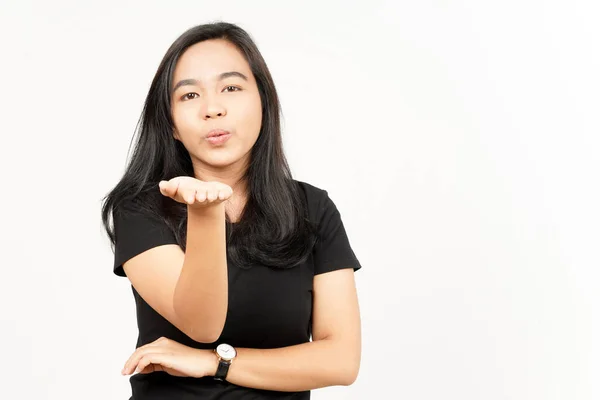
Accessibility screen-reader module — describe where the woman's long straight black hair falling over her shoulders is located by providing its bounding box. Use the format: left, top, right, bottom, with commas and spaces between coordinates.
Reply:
102, 22, 316, 268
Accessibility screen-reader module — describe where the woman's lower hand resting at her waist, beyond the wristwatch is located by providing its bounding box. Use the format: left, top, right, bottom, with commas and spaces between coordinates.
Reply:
121, 337, 218, 378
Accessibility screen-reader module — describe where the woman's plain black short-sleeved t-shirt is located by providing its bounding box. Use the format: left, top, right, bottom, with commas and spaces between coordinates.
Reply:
113, 181, 361, 400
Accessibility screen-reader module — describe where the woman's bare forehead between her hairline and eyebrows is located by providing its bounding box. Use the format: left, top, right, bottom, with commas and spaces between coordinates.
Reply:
173, 39, 252, 82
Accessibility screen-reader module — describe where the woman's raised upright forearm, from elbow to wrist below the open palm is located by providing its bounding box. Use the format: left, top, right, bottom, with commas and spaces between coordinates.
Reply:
173, 204, 228, 341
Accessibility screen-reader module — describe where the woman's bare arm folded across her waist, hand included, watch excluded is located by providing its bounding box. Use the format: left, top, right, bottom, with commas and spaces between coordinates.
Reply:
121, 268, 361, 392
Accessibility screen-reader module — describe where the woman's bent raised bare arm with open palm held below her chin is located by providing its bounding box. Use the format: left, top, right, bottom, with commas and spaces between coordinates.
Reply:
123, 178, 232, 343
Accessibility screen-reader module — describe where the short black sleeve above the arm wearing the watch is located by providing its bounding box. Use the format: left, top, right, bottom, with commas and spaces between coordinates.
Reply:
313, 190, 361, 275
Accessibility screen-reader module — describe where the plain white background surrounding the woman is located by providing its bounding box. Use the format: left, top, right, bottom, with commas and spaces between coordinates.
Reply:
0, 0, 600, 400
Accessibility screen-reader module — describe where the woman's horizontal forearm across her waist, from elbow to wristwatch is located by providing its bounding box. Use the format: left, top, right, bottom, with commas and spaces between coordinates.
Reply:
212, 340, 360, 392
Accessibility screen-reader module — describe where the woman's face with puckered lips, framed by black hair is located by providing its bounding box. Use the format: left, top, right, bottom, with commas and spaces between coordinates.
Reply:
171, 40, 262, 174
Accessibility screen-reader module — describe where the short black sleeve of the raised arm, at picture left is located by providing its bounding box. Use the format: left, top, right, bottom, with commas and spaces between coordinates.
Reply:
113, 203, 177, 276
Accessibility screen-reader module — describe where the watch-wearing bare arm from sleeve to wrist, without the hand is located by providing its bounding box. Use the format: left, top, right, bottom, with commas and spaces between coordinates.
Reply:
211, 268, 361, 391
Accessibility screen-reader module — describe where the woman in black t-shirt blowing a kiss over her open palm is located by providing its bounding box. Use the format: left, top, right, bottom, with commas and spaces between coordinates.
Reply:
102, 22, 361, 400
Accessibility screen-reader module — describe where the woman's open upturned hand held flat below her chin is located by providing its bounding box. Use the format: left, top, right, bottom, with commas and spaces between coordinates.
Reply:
158, 176, 233, 207
